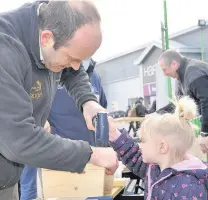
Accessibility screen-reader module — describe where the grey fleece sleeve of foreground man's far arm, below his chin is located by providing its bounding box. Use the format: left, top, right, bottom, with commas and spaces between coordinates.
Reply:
60, 67, 97, 110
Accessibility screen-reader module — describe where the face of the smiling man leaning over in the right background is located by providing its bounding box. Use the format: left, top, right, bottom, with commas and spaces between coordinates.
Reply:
158, 58, 179, 79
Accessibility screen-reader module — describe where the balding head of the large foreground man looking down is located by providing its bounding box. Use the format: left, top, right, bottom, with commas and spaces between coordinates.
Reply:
39, 0, 102, 72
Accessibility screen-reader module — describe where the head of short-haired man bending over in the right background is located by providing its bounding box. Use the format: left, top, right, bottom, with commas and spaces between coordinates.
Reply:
158, 50, 183, 79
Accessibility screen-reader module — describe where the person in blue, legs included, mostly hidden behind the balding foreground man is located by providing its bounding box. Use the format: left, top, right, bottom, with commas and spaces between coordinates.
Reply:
20, 59, 107, 200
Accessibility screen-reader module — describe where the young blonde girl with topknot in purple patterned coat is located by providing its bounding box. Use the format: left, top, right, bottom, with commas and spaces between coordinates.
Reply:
109, 97, 208, 200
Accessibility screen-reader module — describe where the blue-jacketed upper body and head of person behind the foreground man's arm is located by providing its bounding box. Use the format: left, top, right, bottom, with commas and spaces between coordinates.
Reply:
48, 59, 107, 143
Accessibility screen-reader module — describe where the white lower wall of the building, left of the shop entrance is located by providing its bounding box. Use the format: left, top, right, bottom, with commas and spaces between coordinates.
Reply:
103, 76, 143, 111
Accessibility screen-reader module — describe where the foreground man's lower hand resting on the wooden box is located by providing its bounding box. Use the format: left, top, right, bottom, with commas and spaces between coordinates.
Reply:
89, 147, 118, 175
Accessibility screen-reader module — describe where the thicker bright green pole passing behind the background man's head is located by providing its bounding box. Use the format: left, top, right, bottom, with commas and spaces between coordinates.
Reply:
163, 0, 172, 99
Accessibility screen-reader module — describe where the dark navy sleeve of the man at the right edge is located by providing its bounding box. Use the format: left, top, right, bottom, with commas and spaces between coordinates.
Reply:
189, 76, 208, 133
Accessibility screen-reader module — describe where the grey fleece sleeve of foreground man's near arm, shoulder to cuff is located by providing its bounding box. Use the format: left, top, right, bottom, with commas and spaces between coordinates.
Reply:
0, 34, 92, 172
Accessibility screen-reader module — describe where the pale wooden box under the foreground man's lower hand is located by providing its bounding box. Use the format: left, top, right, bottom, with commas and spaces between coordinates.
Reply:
41, 164, 114, 199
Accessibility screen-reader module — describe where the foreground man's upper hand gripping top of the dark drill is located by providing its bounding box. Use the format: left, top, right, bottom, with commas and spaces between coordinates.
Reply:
82, 101, 107, 130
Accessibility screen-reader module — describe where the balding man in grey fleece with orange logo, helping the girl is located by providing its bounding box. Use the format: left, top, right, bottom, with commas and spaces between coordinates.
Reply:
0, 1, 117, 200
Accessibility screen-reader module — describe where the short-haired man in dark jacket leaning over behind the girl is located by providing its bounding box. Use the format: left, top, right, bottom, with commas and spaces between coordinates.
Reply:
159, 50, 208, 153
